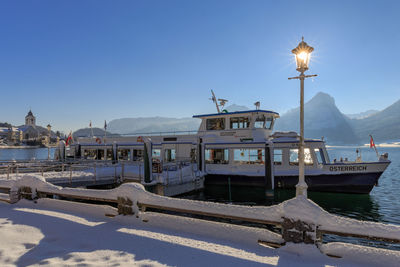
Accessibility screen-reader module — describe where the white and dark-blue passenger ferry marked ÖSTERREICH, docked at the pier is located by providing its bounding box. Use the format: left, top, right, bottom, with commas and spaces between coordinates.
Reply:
61, 98, 390, 193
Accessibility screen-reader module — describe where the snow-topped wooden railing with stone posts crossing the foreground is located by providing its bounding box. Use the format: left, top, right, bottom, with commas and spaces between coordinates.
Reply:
0, 175, 400, 255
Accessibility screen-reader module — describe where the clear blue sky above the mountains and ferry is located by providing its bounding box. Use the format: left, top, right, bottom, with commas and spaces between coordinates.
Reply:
0, 0, 400, 132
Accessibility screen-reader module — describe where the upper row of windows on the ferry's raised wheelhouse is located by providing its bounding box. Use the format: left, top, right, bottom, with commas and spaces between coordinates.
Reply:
206, 115, 273, 130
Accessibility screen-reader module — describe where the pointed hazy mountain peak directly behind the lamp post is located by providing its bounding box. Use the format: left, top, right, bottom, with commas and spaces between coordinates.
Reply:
275, 92, 359, 144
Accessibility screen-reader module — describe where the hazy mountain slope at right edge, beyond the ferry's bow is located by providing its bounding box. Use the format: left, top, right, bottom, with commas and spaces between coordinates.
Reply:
352, 100, 400, 143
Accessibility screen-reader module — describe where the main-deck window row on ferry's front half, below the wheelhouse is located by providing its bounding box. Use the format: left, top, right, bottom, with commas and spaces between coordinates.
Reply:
204, 148, 325, 165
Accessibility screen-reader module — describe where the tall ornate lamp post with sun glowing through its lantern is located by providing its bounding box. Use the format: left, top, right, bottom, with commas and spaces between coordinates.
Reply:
289, 37, 317, 197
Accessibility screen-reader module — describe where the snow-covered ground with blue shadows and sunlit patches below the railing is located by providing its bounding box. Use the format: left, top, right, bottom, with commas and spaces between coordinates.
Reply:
0, 199, 400, 266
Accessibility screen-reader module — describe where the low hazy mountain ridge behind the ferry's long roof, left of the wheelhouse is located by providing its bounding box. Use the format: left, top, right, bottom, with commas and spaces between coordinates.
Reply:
108, 117, 201, 134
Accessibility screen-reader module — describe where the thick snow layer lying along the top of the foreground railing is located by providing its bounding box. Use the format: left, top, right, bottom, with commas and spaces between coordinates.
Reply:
0, 174, 400, 245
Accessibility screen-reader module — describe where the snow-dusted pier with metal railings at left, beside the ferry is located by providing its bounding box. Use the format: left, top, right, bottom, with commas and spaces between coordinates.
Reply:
0, 161, 204, 196
